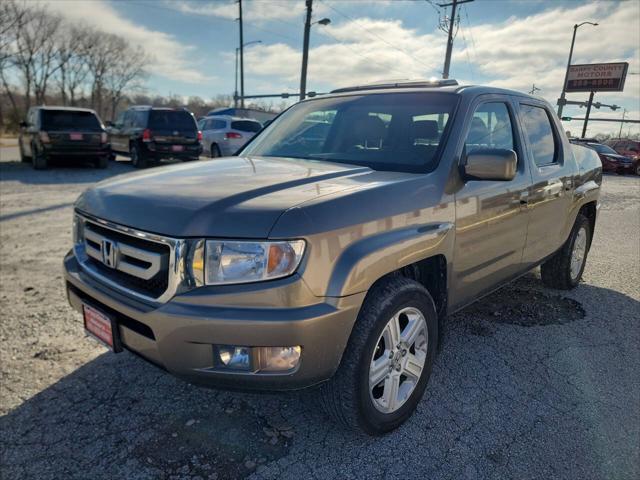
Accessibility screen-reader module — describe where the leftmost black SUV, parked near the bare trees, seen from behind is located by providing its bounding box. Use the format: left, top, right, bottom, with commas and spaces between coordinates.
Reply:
18, 106, 110, 170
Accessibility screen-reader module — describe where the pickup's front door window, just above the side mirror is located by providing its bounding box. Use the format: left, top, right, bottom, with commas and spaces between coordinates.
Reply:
465, 102, 515, 153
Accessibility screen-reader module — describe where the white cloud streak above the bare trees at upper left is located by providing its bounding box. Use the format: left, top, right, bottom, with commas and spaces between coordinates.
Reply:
44, 0, 211, 84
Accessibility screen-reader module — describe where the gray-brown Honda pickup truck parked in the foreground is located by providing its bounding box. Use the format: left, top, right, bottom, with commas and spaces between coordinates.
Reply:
64, 81, 602, 434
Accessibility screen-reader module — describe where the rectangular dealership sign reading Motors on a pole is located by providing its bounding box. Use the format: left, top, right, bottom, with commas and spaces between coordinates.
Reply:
565, 62, 629, 93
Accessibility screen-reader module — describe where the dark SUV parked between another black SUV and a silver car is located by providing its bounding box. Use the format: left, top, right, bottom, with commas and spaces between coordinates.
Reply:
108, 106, 202, 168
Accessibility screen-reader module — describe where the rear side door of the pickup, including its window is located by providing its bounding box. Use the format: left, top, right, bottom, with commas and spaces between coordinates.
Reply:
518, 99, 577, 264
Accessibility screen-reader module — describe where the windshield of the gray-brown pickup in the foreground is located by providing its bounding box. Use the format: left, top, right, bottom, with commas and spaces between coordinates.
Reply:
241, 92, 457, 172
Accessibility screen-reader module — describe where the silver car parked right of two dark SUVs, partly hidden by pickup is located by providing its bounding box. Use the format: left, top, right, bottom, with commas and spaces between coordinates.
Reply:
198, 115, 262, 158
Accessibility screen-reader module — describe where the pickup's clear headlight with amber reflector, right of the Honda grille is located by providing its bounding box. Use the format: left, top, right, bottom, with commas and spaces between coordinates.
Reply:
192, 240, 305, 285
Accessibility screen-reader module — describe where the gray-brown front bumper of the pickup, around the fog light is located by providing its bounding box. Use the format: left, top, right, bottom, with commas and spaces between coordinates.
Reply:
64, 252, 365, 391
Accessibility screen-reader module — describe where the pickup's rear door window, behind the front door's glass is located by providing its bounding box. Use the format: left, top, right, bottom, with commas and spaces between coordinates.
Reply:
520, 105, 558, 167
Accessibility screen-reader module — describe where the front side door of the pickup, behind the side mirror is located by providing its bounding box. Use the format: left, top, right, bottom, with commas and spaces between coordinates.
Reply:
451, 95, 531, 308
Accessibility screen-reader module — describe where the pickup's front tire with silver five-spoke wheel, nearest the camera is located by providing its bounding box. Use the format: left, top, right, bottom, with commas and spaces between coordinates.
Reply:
321, 277, 438, 435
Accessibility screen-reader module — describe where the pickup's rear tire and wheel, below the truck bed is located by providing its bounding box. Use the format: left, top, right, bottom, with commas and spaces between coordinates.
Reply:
540, 213, 592, 290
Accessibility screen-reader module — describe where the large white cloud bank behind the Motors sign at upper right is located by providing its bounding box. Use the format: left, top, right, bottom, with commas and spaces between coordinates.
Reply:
454, 2, 640, 103
